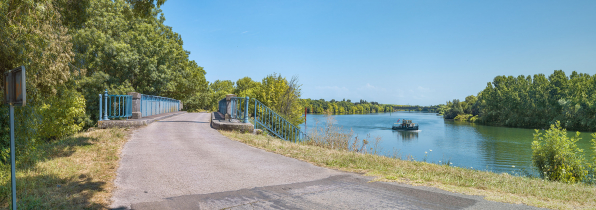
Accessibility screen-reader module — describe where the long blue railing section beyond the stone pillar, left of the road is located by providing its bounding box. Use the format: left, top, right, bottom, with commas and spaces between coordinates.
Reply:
140, 95, 180, 117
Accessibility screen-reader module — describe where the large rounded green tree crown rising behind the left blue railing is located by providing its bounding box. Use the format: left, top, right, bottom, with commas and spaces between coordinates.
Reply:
73, 0, 207, 101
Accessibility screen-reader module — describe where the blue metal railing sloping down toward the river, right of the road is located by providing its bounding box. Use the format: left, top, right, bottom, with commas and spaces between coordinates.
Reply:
253, 99, 308, 142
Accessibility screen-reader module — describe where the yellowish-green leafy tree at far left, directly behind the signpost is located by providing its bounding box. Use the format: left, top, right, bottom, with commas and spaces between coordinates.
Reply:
0, 0, 85, 160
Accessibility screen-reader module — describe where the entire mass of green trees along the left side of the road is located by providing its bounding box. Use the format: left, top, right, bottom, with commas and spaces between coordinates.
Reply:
0, 0, 207, 166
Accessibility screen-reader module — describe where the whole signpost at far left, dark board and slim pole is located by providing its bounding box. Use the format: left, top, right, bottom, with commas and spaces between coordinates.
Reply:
4, 66, 27, 210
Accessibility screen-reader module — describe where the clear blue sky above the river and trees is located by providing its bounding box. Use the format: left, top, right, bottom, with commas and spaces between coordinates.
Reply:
161, 0, 596, 105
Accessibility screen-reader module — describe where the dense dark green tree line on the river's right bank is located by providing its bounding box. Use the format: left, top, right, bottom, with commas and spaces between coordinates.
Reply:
437, 70, 596, 131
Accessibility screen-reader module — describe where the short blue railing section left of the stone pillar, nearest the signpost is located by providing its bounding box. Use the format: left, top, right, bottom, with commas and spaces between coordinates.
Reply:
99, 90, 132, 120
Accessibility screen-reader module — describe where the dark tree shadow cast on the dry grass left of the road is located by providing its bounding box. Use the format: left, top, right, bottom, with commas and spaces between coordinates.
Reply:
0, 133, 112, 209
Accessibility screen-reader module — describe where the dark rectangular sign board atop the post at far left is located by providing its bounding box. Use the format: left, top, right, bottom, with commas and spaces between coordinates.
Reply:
4, 66, 27, 106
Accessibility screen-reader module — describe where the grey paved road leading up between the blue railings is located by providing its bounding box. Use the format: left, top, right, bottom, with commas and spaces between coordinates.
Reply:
111, 113, 544, 209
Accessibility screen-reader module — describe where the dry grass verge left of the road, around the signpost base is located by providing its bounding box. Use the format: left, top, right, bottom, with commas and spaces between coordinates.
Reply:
0, 129, 129, 209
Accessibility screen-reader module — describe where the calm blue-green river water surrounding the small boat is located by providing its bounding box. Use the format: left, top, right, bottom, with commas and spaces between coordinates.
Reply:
301, 112, 593, 175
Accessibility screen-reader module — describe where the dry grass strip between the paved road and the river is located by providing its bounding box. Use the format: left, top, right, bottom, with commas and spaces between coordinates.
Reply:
220, 131, 596, 209
